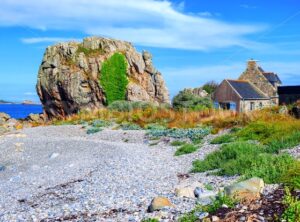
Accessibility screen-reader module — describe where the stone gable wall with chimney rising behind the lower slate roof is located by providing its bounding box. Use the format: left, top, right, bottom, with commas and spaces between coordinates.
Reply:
239, 60, 277, 101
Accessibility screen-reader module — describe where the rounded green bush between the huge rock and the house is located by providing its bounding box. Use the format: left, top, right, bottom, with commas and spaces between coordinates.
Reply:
172, 90, 212, 111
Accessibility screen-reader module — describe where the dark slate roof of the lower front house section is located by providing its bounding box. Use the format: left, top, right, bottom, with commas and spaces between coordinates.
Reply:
227, 80, 269, 99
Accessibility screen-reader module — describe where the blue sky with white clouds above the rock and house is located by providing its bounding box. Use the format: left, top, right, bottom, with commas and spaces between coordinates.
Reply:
0, 0, 300, 102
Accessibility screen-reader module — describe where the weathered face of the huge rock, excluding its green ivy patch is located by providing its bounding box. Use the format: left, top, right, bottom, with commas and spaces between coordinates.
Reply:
37, 37, 170, 118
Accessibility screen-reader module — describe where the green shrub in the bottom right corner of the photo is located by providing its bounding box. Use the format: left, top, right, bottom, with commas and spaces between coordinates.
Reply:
281, 188, 300, 222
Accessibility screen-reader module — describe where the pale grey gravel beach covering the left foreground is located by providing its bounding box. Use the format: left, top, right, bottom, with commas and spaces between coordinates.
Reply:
0, 126, 236, 221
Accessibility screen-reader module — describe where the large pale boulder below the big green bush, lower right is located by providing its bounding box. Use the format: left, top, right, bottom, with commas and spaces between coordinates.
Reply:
224, 177, 264, 200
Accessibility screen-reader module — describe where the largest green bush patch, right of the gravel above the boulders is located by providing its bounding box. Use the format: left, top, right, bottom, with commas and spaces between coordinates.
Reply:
192, 142, 295, 183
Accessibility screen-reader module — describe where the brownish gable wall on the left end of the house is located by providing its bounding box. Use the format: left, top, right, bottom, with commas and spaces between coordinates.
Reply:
213, 80, 240, 112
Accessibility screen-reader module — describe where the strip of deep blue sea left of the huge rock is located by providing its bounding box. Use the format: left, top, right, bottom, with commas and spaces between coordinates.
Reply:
0, 104, 43, 119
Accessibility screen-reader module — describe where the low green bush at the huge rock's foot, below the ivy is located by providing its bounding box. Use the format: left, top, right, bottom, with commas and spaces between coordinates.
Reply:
108, 100, 156, 112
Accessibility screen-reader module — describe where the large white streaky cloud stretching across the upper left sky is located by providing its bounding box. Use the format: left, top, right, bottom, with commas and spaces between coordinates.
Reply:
0, 0, 265, 50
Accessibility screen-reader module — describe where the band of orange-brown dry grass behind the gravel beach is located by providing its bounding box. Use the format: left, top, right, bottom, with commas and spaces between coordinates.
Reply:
48, 107, 300, 132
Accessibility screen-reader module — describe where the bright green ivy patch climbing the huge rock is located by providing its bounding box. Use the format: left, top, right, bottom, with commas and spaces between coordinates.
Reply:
100, 53, 128, 105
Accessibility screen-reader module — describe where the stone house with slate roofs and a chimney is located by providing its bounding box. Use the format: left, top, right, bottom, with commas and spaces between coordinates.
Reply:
213, 60, 281, 112
